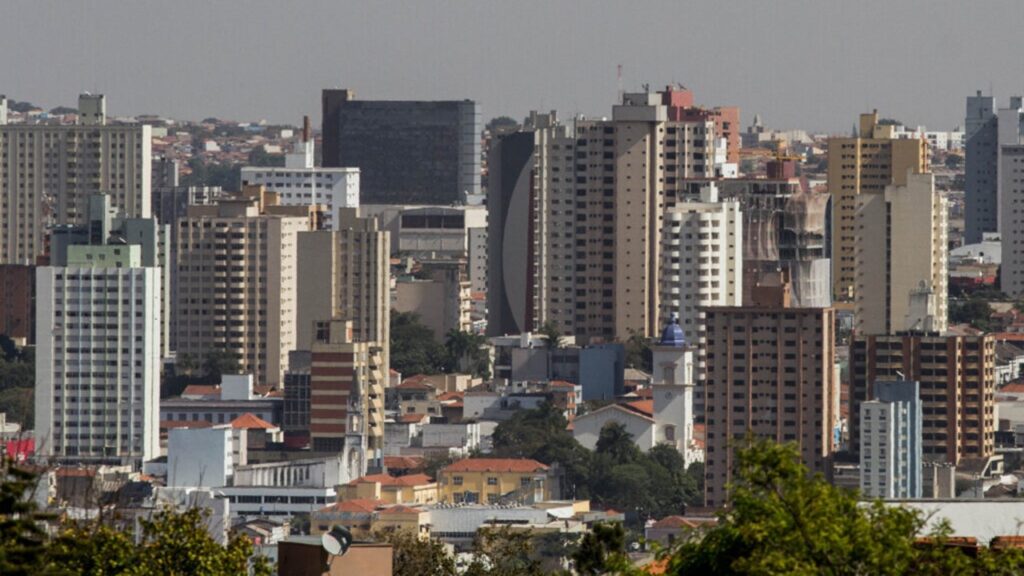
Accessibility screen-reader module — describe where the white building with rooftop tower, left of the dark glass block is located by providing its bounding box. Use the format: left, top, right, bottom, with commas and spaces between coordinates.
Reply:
242, 117, 359, 230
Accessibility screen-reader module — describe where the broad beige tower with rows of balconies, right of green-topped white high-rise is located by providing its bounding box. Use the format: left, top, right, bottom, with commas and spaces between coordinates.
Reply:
175, 188, 313, 384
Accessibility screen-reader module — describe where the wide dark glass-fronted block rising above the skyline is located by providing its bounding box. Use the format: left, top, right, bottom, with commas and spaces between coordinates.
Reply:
323, 89, 483, 205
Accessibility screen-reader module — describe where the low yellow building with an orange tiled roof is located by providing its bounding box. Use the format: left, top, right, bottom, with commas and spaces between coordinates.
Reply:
437, 458, 551, 503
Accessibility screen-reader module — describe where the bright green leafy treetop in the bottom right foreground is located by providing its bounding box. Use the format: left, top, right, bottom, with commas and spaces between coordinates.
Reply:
668, 434, 971, 576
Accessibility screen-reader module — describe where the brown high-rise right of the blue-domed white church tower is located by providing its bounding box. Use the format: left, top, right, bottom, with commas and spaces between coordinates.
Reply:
705, 278, 839, 506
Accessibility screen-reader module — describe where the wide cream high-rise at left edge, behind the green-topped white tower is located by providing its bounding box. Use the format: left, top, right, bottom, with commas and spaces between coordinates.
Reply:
0, 94, 152, 264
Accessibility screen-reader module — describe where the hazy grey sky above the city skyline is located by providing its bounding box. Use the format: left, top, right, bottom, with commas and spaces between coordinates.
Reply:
0, 0, 1024, 131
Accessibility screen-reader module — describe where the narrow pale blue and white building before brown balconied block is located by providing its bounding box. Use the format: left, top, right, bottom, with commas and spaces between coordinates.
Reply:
860, 381, 924, 499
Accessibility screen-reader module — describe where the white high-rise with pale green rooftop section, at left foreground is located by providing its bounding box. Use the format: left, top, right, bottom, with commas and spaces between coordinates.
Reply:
35, 244, 161, 469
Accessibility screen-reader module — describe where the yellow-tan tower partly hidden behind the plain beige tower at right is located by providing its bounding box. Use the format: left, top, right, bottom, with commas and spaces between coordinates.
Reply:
828, 111, 928, 301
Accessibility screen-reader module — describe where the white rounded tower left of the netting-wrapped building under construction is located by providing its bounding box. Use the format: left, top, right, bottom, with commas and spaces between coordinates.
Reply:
659, 182, 743, 342
